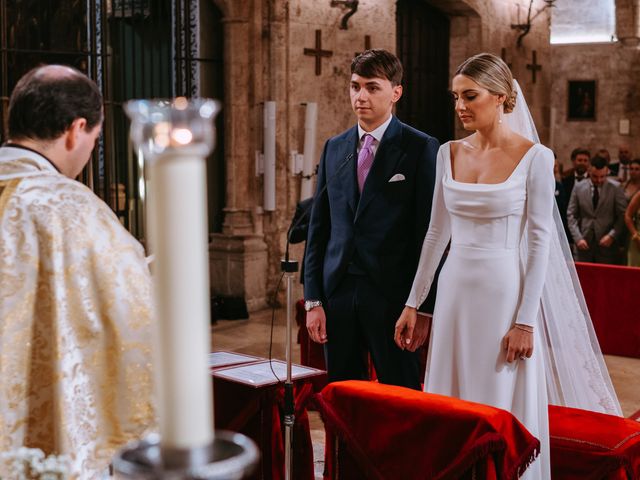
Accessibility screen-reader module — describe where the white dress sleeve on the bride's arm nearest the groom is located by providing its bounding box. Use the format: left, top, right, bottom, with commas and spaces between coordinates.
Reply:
406, 146, 451, 308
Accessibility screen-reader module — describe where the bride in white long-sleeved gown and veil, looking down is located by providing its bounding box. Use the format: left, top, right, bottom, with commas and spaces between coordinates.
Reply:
395, 53, 620, 480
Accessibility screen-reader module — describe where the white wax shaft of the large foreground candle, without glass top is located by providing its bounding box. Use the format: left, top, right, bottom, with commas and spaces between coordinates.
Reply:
149, 150, 213, 449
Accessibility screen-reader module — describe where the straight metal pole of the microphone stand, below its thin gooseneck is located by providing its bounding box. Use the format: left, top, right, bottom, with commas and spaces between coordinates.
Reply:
280, 255, 298, 480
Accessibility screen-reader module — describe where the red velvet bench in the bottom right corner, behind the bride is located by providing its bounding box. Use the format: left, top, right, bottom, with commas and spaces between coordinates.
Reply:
549, 405, 640, 480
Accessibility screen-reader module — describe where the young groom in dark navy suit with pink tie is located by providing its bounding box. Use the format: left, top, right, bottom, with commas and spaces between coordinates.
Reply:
304, 50, 439, 389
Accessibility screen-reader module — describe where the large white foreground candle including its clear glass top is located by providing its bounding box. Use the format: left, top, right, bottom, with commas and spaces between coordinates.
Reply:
125, 98, 220, 449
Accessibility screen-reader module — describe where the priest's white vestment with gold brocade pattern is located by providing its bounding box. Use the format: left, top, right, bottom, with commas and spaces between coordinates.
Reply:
0, 147, 155, 479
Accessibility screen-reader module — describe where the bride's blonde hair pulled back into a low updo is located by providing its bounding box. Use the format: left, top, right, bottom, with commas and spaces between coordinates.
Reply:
454, 53, 516, 113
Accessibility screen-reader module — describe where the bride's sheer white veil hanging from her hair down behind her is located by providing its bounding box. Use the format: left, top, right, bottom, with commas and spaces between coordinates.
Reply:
503, 80, 622, 416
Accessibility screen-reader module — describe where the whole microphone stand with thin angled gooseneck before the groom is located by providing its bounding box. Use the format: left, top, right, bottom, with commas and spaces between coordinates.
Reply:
280, 153, 353, 480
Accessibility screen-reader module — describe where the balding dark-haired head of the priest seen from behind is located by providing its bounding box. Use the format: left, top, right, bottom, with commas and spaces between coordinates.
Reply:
9, 65, 103, 178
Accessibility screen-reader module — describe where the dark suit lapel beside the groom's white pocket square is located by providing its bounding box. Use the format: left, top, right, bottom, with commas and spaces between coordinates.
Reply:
355, 117, 404, 221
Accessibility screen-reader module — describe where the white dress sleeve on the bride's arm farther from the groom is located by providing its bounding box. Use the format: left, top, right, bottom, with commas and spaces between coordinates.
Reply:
516, 149, 555, 326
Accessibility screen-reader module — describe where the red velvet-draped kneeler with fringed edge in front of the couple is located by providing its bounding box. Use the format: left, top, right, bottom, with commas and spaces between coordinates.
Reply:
316, 381, 540, 480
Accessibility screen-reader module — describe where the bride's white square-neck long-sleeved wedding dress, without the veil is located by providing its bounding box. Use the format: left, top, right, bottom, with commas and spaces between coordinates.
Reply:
407, 143, 555, 480
